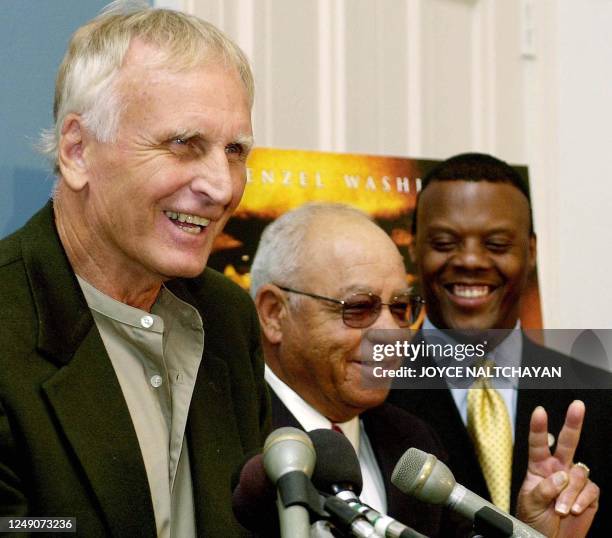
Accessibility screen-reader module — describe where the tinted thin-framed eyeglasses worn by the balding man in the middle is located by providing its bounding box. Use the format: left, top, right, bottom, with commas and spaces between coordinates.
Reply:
277, 285, 425, 329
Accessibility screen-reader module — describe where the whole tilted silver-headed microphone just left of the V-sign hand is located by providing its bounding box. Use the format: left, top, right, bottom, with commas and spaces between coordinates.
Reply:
391, 448, 545, 538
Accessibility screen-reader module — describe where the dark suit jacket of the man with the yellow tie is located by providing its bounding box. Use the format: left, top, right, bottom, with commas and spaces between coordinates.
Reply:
389, 337, 612, 538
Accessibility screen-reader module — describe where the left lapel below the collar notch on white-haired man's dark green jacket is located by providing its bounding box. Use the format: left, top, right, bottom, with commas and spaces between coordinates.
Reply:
43, 326, 155, 536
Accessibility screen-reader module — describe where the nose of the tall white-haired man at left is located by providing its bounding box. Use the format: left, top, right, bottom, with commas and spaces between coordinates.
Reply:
190, 148, 234, 206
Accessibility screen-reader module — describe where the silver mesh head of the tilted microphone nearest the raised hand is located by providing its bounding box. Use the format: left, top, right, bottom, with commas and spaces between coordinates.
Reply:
391, 448, 456, 504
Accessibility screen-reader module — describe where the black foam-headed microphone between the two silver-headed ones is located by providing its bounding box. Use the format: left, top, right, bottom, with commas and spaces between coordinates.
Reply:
308, 429, 427, 538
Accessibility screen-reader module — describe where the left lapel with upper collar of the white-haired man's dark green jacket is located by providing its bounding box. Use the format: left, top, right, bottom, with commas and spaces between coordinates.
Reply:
21, 202, 155, 535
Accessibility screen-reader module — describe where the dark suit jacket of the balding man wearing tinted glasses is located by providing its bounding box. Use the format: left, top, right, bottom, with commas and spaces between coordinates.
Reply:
270, 390, 471, 538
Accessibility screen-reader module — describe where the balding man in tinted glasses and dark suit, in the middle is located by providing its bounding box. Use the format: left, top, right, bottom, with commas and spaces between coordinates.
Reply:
251, 204, 588, 538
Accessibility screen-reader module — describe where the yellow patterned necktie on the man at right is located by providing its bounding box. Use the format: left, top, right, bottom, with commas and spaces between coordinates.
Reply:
467, 360, 512, 512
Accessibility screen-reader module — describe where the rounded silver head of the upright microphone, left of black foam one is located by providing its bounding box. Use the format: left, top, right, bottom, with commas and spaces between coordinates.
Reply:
263, 427, 317, 483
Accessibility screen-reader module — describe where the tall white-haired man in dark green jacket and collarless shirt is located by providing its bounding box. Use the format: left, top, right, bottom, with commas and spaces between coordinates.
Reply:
0, 2, 269, 538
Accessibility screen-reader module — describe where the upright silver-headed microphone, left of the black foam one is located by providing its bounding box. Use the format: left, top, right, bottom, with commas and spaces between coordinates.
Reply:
263, 428, 316, 538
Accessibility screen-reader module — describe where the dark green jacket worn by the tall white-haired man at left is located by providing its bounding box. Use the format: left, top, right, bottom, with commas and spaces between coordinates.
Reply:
0, 203, 270, 538
